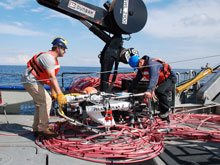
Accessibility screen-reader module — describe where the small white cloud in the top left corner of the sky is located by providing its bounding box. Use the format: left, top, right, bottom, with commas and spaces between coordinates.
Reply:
0, 0, 30, 10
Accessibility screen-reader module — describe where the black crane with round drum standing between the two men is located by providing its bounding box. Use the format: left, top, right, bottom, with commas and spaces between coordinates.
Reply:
37, 0, 147, 92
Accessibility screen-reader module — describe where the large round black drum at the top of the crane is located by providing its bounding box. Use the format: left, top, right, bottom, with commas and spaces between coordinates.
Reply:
111, 0, 147, 34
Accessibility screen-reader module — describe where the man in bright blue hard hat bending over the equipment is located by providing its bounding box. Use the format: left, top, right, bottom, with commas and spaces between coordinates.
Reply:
128, 55, 176, 121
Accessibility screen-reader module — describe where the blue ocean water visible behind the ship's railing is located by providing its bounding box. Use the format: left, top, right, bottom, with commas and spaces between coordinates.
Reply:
0, 65, 212, 87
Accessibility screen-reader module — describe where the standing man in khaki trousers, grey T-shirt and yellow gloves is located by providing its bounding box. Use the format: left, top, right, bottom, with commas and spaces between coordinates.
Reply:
21, 37, 67, 138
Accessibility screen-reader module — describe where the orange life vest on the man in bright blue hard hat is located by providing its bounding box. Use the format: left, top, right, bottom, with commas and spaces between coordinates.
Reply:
142, 59, 171, 85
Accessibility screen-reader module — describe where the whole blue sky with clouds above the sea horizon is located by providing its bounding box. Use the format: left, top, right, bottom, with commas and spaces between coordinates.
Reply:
0, 0, 220, 69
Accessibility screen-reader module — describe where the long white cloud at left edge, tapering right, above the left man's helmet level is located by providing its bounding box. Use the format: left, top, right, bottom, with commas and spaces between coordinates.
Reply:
0, 22, 45, 36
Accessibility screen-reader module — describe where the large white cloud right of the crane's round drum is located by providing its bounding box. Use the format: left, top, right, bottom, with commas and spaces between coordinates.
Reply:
144, 0, 220, 41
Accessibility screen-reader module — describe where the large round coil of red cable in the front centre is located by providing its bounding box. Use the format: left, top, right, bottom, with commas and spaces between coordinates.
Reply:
36, 125, 164, 164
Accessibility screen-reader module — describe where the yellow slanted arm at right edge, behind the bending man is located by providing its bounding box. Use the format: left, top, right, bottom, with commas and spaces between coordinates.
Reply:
176, 64, 220, 93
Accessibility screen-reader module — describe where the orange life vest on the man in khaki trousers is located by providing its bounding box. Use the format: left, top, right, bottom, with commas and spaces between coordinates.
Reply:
27, 52, 60, 86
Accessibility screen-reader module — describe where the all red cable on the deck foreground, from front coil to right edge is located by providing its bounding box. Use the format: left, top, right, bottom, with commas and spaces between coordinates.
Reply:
36, 113, 220, 164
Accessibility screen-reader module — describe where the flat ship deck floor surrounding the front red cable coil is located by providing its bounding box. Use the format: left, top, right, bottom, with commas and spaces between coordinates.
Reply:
0, 114, 220, 165
